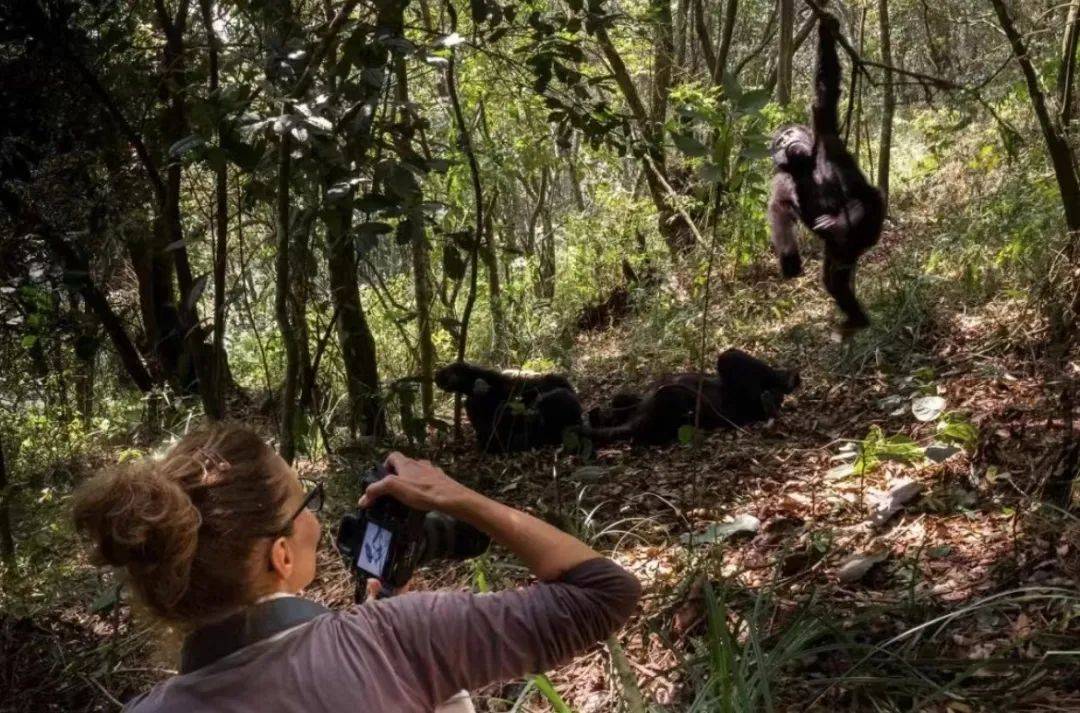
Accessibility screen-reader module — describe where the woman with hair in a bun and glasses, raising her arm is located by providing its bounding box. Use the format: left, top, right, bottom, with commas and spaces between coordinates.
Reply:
75, 425, 640, 713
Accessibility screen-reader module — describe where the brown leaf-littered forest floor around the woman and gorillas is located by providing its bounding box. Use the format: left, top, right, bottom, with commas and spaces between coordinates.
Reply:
0, 220, 1080, 713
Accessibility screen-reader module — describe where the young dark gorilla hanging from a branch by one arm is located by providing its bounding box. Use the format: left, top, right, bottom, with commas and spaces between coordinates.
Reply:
769, 15, 885, 333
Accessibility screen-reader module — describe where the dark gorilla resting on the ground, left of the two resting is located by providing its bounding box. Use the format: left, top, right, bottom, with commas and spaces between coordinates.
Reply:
435, 363, 581, 453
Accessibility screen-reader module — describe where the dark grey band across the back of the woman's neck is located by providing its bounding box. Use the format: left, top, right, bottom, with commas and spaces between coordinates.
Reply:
180, 596, 329, 673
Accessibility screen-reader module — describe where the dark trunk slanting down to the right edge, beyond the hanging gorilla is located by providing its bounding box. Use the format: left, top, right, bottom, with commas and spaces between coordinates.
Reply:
990, 0, 1080, 232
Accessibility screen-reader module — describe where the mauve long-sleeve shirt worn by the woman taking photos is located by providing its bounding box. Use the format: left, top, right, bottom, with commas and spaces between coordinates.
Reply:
124, 557, 642, 713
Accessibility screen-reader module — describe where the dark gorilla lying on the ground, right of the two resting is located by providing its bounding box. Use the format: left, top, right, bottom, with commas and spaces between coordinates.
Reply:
583, 349, 799, 444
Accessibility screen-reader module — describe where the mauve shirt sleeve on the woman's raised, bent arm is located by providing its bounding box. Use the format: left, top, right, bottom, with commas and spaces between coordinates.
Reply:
338, 557, 642, 709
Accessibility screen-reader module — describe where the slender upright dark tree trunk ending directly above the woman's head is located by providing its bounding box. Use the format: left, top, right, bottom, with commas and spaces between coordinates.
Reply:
199, 0, 229, 414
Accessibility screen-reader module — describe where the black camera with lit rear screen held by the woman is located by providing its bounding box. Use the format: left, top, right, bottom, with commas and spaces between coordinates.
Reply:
337, 466, 491, 594
